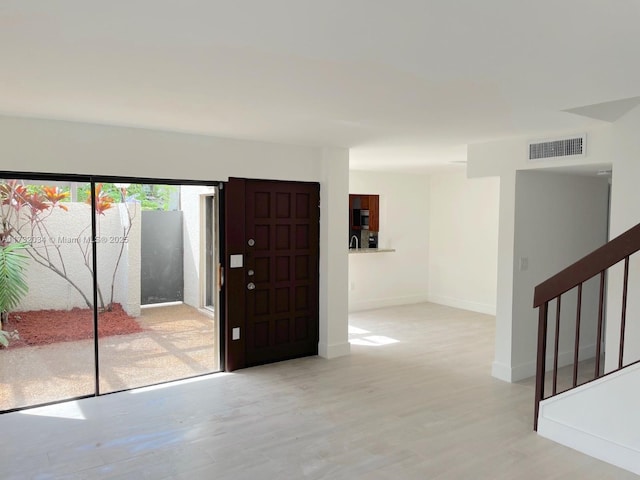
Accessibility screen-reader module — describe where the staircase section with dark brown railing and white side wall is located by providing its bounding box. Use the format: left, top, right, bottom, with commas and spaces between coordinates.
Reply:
534, 224, 640, 474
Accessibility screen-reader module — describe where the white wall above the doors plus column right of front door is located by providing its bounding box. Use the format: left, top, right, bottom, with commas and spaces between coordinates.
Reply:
0, 116, 349, 356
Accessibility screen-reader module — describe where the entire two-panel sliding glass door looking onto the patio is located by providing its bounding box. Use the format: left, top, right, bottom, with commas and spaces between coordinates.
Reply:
0, 175, 220, 411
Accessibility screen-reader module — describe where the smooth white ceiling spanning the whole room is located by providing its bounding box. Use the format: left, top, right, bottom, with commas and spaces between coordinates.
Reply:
0, 0, 640, 172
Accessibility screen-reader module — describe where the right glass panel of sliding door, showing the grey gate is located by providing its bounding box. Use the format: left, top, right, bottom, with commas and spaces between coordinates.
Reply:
95, 183, 219, 393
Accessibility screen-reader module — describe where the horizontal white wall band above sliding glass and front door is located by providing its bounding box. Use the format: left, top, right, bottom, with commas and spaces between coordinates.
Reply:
0, 116, 322, 181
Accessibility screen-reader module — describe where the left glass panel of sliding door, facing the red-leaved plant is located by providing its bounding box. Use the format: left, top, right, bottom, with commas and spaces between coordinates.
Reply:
0, 178, 96, 411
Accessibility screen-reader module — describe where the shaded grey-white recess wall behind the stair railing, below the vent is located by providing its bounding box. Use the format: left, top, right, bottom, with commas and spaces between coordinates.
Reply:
511, 171, 609, 380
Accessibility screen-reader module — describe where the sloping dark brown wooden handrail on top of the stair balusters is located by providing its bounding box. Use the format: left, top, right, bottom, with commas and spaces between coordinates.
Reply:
533, 224, 640, 308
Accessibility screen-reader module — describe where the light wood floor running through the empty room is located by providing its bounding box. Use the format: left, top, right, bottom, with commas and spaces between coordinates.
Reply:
0, 304, 637, 480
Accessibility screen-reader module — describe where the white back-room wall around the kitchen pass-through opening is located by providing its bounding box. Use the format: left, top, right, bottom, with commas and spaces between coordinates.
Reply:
340, 170, 429, 311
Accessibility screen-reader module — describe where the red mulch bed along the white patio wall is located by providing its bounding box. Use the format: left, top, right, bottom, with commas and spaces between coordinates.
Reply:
5, 303, 142, 348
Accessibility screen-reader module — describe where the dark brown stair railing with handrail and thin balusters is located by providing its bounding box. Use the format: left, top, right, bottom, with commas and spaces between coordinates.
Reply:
533, 224, 640, 430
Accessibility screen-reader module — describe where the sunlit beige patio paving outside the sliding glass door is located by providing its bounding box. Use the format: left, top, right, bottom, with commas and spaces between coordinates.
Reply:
0, 304, 220, 410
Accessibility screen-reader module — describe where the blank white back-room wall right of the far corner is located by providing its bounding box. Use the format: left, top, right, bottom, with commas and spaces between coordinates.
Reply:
428, 171, 500, 315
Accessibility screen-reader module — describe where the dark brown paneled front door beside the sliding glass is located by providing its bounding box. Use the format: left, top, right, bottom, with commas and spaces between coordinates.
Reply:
226, 179, 320, 370
